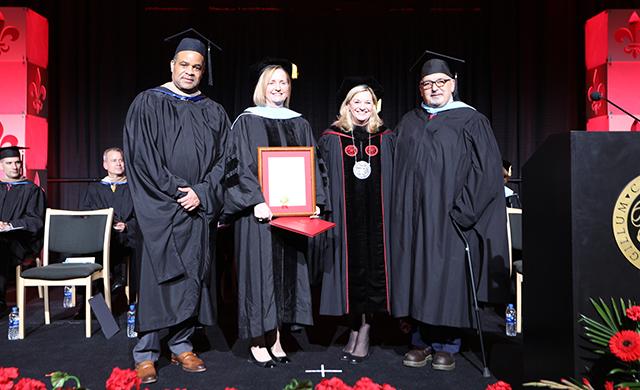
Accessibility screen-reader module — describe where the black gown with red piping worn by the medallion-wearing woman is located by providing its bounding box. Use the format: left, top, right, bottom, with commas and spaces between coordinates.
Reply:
313, 127, 394, 315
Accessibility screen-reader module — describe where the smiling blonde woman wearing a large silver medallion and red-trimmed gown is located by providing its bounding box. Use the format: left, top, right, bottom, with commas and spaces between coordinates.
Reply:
314, 77, 394, 364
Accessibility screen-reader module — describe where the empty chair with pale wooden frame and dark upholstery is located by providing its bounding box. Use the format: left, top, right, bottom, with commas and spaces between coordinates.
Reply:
16, 208, 113, 339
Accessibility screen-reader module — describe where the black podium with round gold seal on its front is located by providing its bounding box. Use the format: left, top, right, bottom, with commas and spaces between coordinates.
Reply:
522, 131, 640, 381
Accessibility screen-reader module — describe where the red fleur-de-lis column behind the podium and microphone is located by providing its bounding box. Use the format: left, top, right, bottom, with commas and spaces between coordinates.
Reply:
585, 9, 640, 131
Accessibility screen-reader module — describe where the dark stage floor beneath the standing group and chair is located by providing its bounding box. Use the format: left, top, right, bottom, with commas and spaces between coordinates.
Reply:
0, 288, 522, 390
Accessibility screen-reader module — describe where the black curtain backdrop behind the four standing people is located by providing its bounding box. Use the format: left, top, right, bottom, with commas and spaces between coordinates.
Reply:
2, 0, 638, 208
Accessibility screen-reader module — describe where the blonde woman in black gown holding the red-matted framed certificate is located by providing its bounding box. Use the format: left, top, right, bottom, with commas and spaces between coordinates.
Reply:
224, 59, 327, 368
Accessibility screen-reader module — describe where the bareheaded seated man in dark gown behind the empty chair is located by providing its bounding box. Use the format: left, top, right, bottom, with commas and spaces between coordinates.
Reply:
80, 148, 138, 290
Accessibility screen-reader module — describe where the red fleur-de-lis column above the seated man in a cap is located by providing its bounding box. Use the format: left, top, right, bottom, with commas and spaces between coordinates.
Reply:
0, 7, 49, 180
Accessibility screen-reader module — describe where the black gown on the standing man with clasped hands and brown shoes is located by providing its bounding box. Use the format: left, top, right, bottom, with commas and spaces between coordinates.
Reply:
124, 87, 229, 331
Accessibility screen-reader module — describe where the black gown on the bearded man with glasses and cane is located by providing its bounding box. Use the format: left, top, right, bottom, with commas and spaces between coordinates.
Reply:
390, 108, 509, 327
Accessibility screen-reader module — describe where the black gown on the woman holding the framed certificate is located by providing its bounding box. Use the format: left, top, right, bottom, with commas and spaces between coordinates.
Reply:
224, 109, 327, 338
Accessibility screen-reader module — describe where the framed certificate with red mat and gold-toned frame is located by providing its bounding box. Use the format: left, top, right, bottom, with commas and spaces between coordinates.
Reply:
258, 146, 316, 216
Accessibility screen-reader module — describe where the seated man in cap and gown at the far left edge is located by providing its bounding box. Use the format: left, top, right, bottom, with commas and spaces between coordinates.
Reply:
0, 146, 46, 316
